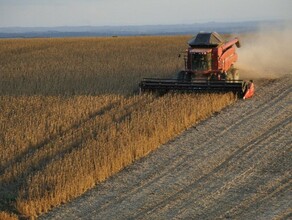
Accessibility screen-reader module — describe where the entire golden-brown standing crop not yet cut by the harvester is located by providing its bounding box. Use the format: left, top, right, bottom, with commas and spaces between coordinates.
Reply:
0, 37, 235, 216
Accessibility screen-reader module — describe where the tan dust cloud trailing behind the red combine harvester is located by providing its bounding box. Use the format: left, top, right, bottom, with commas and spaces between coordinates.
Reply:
236, 24, 292, 79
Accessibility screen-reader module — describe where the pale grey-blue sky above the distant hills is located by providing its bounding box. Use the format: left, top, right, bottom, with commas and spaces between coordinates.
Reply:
0, 0, 292, 27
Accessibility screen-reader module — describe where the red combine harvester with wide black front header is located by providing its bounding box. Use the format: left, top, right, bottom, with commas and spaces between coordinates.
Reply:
139, 32, 254, 99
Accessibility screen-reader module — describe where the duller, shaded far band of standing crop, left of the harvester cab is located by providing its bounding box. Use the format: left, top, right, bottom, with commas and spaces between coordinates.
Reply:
0, 37, 187, 95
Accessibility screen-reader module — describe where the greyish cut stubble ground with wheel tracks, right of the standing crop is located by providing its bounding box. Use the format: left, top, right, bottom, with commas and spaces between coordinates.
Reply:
40, 76, 292, 219
